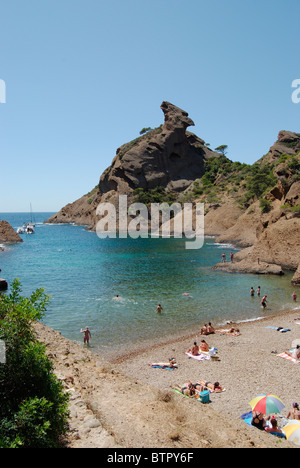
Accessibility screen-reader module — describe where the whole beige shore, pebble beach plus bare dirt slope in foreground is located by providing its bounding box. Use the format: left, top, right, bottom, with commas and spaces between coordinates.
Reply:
37, 311, 300, 448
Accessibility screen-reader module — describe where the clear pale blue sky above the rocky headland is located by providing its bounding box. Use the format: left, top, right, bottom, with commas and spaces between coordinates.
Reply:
0, 0, 300, 212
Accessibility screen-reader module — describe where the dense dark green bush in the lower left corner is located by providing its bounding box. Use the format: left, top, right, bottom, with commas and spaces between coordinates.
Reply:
0, 280, 68, 448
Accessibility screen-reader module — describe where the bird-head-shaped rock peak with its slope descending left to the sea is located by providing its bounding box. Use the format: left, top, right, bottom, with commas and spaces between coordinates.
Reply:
46, 101, 219, 229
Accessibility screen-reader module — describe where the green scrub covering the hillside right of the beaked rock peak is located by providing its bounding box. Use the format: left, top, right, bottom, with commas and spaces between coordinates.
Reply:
132, 149, 300, 217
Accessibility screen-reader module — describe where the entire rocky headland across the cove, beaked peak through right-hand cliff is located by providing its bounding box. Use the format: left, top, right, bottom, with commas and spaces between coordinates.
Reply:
46, 102, 300, 285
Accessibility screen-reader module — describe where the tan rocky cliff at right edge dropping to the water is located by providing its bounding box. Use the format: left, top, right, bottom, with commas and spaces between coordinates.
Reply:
206, 131, 300, 284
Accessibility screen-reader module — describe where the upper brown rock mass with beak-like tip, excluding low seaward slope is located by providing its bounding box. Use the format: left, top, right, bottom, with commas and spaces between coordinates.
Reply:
99, 101, 219, 194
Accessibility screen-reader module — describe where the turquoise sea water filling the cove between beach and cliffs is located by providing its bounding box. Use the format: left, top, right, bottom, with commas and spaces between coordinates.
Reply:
0, 213, 296, 354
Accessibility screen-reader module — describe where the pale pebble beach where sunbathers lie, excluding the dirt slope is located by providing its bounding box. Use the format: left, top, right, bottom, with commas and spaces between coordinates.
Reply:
113, 311, 300, 422
